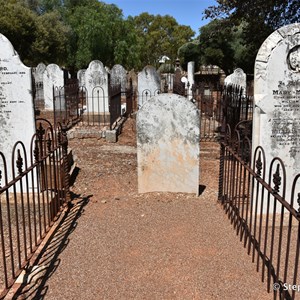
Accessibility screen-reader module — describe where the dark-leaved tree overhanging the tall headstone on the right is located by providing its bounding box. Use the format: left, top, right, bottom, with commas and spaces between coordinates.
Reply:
205, 0, 300, 73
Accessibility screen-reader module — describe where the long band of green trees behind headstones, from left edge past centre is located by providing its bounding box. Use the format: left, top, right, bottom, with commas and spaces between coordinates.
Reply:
0, 0, 194, 74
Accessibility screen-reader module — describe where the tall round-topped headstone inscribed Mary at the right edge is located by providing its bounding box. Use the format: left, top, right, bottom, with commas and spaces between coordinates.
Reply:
253, 23, 300, 209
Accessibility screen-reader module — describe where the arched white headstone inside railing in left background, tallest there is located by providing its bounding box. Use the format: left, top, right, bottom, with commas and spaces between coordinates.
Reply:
85, 60, 109, 123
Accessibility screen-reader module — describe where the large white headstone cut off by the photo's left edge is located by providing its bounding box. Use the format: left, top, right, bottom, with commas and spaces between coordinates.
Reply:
0, 34, 35, 180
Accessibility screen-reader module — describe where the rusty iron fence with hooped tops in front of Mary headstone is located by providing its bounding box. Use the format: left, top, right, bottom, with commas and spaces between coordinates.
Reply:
218, 117, 300, 299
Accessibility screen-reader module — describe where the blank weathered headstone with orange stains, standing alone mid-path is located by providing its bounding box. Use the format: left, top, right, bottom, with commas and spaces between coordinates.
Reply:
137, 94, 200, 195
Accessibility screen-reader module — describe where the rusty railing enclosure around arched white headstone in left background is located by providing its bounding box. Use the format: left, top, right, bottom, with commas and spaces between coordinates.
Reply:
38, 79, 127, 129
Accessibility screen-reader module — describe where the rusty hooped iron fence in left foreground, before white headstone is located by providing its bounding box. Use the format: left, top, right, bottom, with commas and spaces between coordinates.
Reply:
0, 119, 70, 297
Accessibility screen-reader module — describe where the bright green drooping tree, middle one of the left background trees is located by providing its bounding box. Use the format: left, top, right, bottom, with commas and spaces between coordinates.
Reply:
66, 1, 124, 68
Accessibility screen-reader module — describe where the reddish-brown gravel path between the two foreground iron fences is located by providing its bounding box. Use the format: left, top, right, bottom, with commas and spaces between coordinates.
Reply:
9, 121, 273, 300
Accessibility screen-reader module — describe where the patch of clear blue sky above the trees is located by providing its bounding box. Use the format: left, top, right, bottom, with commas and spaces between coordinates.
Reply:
102, 0, 216, 35
